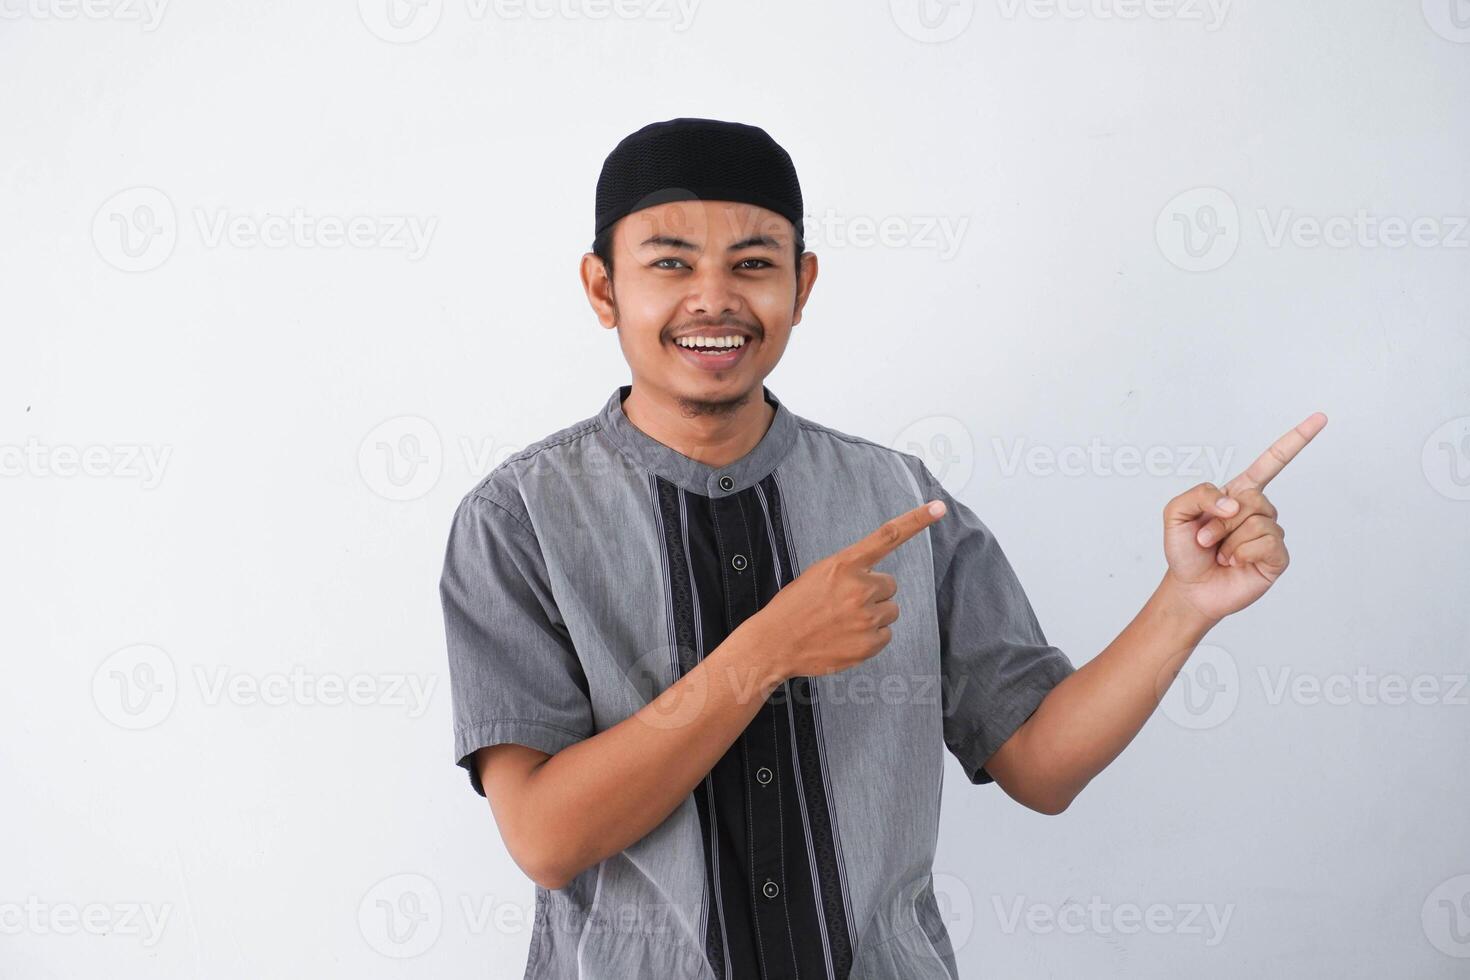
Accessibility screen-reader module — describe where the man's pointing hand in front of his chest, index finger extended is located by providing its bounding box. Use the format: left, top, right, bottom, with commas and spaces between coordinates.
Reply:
747, 500, 945, 680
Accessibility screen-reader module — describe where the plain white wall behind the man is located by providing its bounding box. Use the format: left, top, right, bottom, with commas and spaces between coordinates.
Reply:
0, 0, 1470, 980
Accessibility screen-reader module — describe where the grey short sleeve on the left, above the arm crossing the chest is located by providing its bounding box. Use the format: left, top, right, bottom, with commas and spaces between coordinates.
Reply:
440, 489, 592, 796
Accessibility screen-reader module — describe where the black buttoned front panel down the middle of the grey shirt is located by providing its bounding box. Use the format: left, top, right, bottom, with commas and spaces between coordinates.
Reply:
656, 470, 848, 980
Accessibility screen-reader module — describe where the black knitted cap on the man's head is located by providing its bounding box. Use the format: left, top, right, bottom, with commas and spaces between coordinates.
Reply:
592, 119, 806, 245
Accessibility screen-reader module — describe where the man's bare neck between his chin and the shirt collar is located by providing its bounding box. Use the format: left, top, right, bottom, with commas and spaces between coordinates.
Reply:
623, 382, 776, 469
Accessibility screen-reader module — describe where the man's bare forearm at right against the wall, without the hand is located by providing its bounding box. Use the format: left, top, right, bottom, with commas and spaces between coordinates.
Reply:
988, 574, 1214, 813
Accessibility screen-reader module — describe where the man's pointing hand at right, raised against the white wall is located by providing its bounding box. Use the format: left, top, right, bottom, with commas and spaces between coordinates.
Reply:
1164, 411, 1327, 621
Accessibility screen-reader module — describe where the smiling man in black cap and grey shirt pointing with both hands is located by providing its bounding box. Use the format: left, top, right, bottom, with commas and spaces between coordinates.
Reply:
441, 119, 1326, 980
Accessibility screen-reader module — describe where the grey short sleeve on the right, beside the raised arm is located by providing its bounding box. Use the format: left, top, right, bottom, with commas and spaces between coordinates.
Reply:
920, 463, 1076, 783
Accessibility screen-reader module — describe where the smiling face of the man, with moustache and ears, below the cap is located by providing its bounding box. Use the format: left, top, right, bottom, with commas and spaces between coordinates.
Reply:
582, 201, 817, 414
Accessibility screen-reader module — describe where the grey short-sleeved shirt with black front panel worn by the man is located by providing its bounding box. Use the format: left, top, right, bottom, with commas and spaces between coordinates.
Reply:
440, 385, 1073, 980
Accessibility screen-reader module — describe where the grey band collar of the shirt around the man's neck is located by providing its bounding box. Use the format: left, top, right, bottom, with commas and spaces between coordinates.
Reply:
598, 385, 797, 497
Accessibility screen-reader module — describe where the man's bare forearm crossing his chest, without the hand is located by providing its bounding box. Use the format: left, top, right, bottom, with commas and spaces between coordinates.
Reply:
517, 620, 782, 887
